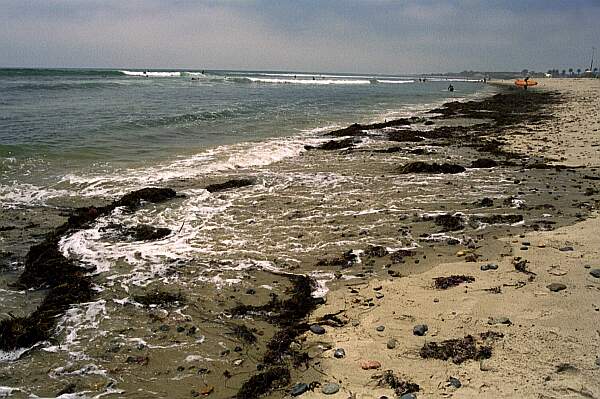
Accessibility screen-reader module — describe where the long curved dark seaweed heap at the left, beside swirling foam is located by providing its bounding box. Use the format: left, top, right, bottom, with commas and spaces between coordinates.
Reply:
0, 188, 176, 351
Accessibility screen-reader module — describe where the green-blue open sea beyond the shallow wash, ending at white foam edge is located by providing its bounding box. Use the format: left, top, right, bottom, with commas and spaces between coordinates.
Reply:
0, 69, 489, 207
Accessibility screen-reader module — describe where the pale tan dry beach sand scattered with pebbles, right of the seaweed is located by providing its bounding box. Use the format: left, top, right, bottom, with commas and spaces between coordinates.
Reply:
302, 79, 600, 398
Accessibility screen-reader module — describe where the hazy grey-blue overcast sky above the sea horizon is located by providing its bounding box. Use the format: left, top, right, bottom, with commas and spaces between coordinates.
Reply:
0, 0, 600, 73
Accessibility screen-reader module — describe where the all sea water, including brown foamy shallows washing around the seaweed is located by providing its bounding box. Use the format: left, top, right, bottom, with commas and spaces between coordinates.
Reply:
0, 70, 502, 398
